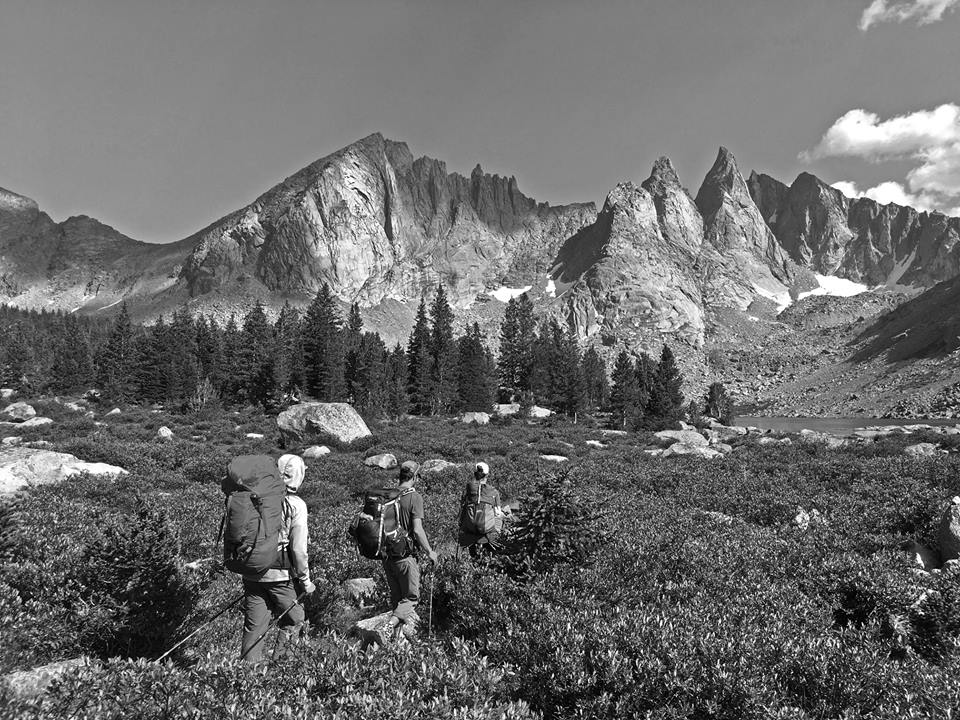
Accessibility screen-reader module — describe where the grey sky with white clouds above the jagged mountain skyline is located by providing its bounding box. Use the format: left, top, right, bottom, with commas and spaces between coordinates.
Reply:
0, 0, 960, 242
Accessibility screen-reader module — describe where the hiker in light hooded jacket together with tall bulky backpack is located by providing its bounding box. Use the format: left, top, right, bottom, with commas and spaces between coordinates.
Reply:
222, 455, 316, 663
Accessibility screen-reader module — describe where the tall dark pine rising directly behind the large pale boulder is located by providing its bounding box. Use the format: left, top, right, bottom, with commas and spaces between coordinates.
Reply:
303, 283, 346, 402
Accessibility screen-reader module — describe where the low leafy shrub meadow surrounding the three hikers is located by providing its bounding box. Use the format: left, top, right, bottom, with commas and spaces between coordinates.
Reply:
0, 403, 960, 720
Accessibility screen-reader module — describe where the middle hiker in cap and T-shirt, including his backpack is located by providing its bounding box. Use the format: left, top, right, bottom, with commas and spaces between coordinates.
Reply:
350, 460, 437, 635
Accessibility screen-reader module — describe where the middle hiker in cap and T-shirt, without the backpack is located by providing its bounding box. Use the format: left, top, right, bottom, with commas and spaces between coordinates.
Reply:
383, 460, 437, 635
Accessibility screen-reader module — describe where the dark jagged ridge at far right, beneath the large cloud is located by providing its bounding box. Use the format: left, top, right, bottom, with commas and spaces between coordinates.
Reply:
749, 173, 960, 287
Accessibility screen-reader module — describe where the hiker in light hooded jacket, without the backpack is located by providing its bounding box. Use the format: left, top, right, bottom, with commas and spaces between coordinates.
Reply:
240, 455, 316, 663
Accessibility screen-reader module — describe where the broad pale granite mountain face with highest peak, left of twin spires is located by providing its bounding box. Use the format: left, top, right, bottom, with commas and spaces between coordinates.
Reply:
173, 134, 596, 306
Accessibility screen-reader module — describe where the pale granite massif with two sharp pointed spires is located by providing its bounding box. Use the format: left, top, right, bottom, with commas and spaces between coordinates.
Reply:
554, 149, 812, 347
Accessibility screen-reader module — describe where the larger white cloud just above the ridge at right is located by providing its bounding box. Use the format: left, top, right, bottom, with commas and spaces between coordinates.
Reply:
800, 103, 960, 214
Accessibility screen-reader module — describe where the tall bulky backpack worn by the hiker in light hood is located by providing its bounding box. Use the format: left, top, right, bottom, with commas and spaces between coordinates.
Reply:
220, 455, 287, 575
